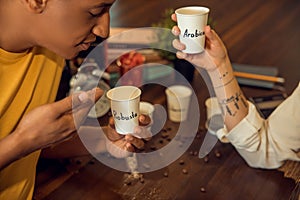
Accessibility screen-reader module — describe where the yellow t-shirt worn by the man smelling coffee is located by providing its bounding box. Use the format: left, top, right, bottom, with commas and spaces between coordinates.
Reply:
0, 47, 64, 200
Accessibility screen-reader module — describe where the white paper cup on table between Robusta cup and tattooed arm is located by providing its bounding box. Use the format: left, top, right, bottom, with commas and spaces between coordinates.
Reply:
165, 85, 192, 122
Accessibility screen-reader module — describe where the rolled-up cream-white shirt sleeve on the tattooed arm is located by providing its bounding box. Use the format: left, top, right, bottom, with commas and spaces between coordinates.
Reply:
218, 83, 300, 168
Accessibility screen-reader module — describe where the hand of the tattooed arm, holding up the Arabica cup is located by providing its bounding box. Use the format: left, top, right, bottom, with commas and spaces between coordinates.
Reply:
171, 14, 229, 71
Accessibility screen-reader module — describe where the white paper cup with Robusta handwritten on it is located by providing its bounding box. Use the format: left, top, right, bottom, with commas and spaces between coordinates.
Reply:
106, 86, 141, 135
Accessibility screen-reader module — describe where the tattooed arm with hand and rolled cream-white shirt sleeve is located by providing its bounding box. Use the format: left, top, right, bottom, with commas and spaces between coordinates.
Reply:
172, 14, 300, 168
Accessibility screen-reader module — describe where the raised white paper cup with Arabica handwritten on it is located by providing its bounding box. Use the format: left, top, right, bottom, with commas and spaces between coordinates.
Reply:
175, 6, 209, 54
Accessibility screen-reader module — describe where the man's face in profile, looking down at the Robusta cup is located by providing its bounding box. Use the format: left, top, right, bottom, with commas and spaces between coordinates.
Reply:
35, 0, 115, 59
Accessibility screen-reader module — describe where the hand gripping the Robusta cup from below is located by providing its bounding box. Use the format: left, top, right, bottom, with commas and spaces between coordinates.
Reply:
105, 115, 152, 158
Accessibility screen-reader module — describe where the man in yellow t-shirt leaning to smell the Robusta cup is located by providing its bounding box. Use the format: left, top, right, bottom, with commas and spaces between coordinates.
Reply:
0, 0, 149, 199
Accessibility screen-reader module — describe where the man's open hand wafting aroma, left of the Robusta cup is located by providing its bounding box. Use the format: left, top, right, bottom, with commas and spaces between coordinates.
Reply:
15, 88, 103, 151
